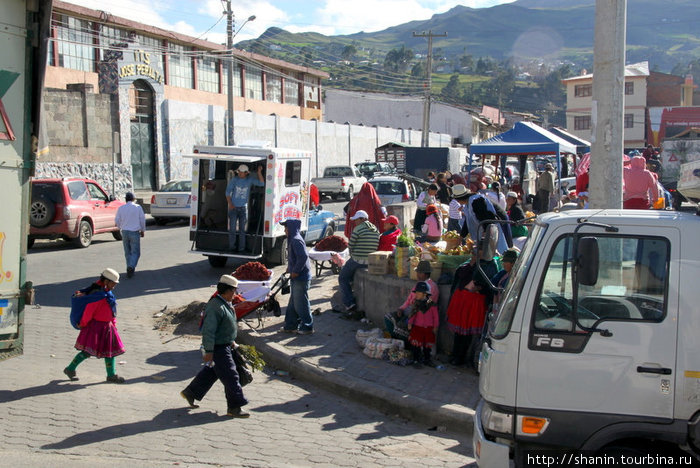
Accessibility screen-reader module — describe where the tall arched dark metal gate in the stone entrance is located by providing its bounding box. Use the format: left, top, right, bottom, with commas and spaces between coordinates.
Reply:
129, 80, 156, 190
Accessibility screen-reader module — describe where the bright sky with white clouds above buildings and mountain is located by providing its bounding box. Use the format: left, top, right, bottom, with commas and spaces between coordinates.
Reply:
66, 0, 514, 44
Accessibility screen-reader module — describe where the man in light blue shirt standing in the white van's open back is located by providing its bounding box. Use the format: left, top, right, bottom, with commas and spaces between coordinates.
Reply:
226, 164, 265, 252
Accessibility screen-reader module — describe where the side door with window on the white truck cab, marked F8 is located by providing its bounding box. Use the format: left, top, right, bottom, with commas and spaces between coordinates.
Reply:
516, 226, 680, 420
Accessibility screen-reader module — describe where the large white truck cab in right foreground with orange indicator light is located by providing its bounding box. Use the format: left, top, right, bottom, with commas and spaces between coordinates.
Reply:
473, 210, 700, 468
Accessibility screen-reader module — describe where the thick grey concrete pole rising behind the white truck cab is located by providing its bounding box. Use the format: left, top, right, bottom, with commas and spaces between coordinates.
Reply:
589, 0, 627, 209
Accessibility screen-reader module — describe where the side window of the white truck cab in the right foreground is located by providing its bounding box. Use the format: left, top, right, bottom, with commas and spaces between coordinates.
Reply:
534, 236, 670, 332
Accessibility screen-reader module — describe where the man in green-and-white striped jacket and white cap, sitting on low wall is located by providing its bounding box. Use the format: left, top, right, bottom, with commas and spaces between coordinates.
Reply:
338, 210, 379, 316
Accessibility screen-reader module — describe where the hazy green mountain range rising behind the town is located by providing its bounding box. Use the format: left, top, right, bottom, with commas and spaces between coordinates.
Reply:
238, 0, 700, 71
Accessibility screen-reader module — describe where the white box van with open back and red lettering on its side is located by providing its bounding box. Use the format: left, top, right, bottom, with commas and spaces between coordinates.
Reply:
184, 146, 311, 267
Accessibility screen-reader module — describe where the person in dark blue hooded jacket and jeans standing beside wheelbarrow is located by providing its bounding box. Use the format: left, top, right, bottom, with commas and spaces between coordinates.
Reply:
280, 219, 314, 335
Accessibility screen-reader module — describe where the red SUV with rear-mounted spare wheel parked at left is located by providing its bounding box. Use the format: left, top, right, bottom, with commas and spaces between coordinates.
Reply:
27, 178, 124, 248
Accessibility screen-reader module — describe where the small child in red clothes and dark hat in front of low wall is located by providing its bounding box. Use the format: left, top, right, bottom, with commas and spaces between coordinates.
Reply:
408, 281, 440, 367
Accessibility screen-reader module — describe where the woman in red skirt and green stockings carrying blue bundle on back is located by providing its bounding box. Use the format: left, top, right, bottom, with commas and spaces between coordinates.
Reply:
63, 268, 125, 384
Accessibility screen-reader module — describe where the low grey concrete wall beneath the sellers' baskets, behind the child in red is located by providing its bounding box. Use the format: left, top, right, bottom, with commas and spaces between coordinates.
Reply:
353, 270, 452, 353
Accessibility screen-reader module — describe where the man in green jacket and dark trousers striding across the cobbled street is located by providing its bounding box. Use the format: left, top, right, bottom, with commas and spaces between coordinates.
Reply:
180, 275, 250, 418
